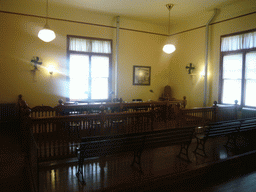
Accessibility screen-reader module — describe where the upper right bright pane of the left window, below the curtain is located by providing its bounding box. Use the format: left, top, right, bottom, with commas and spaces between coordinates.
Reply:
91, 56, 109, 77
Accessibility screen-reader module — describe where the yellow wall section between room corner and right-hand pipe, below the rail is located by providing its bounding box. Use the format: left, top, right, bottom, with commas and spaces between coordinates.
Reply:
168, 28, 205, 107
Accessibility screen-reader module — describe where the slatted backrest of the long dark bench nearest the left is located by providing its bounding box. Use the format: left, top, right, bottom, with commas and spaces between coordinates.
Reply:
80, 127, 195, 157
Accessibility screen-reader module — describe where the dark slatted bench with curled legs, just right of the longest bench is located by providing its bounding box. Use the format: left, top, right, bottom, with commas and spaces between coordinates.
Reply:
194, 120, 241, 156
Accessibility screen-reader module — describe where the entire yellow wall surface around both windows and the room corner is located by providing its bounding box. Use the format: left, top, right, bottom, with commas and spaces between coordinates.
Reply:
0, 0, 256, 108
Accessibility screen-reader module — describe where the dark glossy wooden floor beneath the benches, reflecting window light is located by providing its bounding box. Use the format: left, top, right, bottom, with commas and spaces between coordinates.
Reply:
39, 134, 256, 192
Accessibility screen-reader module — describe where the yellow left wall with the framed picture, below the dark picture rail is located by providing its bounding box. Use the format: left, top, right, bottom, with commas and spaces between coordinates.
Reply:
0, 12, 170, 107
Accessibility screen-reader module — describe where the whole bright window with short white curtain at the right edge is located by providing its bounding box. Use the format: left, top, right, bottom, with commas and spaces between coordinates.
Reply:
219, 30, 256, 107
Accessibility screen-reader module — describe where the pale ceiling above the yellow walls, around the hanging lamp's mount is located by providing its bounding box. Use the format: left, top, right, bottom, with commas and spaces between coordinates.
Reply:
53, 0, 243, 24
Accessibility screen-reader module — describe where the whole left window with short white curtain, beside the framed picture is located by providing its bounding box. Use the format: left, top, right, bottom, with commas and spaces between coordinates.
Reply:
67, 36, 112, 102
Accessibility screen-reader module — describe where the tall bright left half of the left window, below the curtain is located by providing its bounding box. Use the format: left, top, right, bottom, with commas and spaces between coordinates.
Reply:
69, 54, 89, 101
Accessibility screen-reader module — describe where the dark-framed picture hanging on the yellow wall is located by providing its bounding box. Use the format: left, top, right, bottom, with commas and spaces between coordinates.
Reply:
133, 65, 151, 85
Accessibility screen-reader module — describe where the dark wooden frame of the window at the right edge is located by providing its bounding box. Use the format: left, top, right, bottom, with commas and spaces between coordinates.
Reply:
218, 29, 256, 108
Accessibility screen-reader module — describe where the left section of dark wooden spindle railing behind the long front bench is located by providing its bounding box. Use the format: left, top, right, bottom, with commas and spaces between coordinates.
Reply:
29, 111, 154, 161
